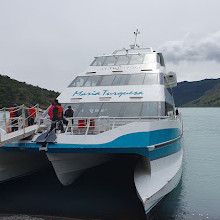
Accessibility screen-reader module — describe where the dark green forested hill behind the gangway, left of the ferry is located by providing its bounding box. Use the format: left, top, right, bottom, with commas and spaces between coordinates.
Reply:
0, 75, 59, 109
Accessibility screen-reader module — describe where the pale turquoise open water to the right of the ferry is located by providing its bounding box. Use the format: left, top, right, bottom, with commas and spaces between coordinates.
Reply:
152, 108, 220, 220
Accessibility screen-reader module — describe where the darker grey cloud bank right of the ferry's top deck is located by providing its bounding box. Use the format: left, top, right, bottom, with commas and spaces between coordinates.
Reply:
159, 31, 220, 64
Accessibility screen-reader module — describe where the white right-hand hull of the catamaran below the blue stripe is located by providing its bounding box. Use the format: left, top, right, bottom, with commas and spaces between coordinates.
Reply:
134, 150, 183, 213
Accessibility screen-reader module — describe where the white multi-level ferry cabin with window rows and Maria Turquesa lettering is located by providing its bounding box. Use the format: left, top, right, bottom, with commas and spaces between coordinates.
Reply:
47, 48, 176, 135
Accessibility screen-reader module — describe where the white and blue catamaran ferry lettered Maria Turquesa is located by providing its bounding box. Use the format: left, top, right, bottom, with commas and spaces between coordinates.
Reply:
0, 45, 183, 213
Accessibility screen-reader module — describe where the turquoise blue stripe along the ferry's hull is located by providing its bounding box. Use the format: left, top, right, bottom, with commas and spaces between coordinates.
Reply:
2, 128, 181, 160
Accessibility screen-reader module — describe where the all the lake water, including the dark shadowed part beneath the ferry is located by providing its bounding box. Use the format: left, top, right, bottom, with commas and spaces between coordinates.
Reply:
0, 108, 220, 220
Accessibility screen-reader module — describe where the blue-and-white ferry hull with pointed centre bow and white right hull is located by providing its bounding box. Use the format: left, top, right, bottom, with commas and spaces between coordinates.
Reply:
47, 119, 183, 213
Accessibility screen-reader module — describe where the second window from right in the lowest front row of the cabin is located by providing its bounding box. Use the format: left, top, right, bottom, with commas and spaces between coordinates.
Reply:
122, 102, 142, 117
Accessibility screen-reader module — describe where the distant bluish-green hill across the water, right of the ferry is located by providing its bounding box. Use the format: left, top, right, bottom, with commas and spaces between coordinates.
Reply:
173, 79, 220, 107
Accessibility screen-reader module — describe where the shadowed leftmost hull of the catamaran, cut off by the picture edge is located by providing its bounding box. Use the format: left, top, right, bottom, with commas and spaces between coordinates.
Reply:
0, 151, 49, 182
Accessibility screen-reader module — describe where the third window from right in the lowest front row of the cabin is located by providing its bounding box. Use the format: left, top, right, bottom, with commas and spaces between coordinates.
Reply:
98, 103, 123, 117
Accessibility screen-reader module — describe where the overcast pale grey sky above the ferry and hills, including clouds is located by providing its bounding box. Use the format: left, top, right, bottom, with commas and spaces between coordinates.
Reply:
0, 0, 220, 91
